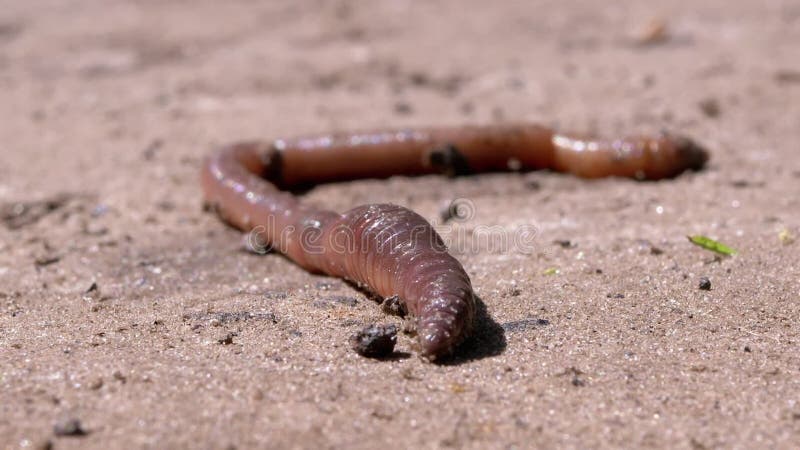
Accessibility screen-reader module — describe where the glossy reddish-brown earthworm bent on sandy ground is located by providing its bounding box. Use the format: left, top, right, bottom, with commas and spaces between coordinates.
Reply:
202, 124, 708, 360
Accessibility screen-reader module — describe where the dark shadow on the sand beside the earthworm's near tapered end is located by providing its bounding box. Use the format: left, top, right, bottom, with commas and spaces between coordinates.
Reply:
436, 295, 508, 366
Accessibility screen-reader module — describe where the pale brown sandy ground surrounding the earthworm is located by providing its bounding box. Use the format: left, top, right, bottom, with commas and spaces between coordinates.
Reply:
0, 0, 800, 449
